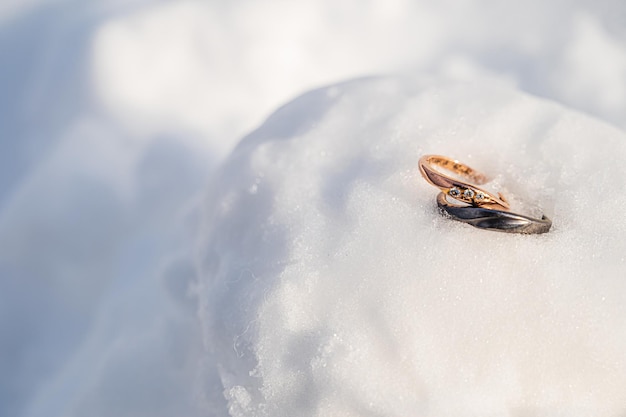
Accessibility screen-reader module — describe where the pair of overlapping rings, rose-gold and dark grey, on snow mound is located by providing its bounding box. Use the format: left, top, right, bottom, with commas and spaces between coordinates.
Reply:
419, 155, 552, 233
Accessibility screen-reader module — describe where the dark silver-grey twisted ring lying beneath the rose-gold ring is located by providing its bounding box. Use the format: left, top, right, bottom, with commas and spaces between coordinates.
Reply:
437, 192, 552, 234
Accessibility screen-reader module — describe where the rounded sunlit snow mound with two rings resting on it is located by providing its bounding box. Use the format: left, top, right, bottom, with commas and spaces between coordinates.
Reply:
199, 77, 626, 417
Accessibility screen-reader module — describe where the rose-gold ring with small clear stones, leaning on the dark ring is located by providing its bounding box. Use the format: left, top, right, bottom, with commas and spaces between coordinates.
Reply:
419, 155, 509, 210
